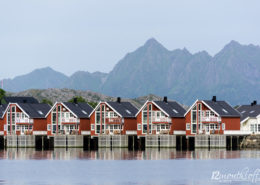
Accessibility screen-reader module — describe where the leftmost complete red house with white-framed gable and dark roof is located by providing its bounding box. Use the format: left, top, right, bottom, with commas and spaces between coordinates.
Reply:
2, 100, 50, 135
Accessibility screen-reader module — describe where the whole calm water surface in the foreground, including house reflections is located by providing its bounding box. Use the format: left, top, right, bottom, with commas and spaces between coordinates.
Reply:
0, 149, 260, 185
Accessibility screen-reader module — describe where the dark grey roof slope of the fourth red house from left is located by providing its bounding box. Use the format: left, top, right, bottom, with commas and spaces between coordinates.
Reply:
154, 101, 186, 118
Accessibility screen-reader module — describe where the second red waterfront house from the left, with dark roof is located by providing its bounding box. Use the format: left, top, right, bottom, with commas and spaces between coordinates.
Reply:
46, 100, 93, 136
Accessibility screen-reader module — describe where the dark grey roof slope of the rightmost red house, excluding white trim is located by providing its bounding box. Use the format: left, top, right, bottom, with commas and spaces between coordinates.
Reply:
203, 100, 241, 117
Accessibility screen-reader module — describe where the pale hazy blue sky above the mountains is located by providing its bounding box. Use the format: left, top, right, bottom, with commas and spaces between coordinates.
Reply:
0, 0, 260, 79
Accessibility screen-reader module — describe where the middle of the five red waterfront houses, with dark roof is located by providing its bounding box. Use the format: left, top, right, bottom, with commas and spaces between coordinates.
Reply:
90, 98, 138, 136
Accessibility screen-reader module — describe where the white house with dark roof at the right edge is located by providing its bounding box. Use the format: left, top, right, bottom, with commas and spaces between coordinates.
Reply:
237, 101, 260, 134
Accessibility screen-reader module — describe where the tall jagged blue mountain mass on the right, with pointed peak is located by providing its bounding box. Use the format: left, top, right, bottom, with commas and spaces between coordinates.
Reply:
101, 39, 260, 104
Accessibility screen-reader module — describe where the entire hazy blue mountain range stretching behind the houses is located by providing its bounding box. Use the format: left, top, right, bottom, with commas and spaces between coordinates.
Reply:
4, 38, 260, 105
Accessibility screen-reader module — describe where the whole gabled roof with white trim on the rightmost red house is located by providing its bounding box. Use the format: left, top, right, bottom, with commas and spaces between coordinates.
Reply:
185, 100, 241, 117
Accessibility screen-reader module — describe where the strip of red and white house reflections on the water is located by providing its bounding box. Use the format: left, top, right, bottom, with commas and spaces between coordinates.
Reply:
0, 148, 260, 160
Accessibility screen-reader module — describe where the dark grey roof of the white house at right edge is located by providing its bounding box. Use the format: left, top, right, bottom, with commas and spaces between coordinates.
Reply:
237, 105, 260, 121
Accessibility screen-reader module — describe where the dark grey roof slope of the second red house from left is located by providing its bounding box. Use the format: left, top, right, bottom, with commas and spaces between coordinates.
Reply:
63, 102, 93, 118
